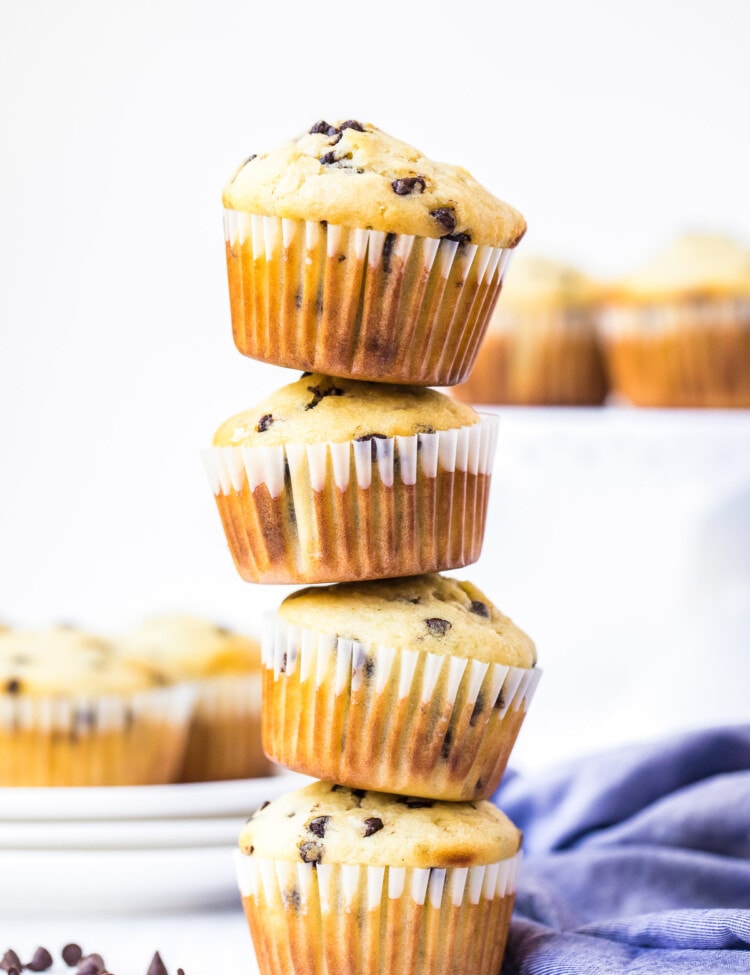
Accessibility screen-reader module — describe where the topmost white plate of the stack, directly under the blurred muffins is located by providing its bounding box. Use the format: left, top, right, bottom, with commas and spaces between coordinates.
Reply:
0, 771, 311, 822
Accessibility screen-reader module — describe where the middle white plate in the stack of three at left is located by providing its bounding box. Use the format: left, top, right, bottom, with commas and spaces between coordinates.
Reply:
0, 814, 247, 852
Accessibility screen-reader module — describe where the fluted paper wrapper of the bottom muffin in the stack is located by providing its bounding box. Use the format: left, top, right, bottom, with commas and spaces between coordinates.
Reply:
236, 852, 521, 975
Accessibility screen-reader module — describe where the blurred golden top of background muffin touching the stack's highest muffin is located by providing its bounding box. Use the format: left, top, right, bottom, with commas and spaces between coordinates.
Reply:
495, 253, 602, 314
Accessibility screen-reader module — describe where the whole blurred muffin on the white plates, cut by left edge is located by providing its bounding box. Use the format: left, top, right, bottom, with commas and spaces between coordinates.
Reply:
0, 628, 194, 786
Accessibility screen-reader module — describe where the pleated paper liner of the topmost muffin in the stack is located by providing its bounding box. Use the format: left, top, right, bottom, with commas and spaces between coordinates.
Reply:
224, 209, 512, 386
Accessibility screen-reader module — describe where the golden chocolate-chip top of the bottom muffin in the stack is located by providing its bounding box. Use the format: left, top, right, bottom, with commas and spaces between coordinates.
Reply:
240, 782, 521, 868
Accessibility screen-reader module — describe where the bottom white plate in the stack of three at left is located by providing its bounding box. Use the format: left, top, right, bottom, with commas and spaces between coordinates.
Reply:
0, 846, 240, 929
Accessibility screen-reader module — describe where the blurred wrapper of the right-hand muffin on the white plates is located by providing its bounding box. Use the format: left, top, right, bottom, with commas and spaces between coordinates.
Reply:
180, 672, 270, 782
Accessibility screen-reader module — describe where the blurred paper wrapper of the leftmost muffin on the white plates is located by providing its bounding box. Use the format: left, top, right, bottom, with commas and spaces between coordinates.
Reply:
0, 683, 196, 786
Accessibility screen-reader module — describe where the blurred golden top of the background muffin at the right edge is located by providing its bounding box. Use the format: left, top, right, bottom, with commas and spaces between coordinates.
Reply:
612, 234, 750, 301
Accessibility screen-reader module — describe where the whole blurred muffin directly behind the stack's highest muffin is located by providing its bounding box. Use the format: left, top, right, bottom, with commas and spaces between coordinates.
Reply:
454, 254, 608, 406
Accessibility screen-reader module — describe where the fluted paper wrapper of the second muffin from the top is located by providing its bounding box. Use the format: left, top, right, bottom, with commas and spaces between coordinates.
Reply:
202, 416, 497, 584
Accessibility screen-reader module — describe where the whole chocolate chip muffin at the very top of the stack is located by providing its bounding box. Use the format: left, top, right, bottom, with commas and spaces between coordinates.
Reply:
223, 119, 526, 386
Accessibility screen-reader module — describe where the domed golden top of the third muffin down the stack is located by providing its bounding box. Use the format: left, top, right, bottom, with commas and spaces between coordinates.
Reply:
278, 573, 536, 667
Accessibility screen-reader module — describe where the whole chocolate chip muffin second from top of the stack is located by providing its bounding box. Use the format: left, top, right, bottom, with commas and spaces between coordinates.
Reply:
203, 373, 497, 584
